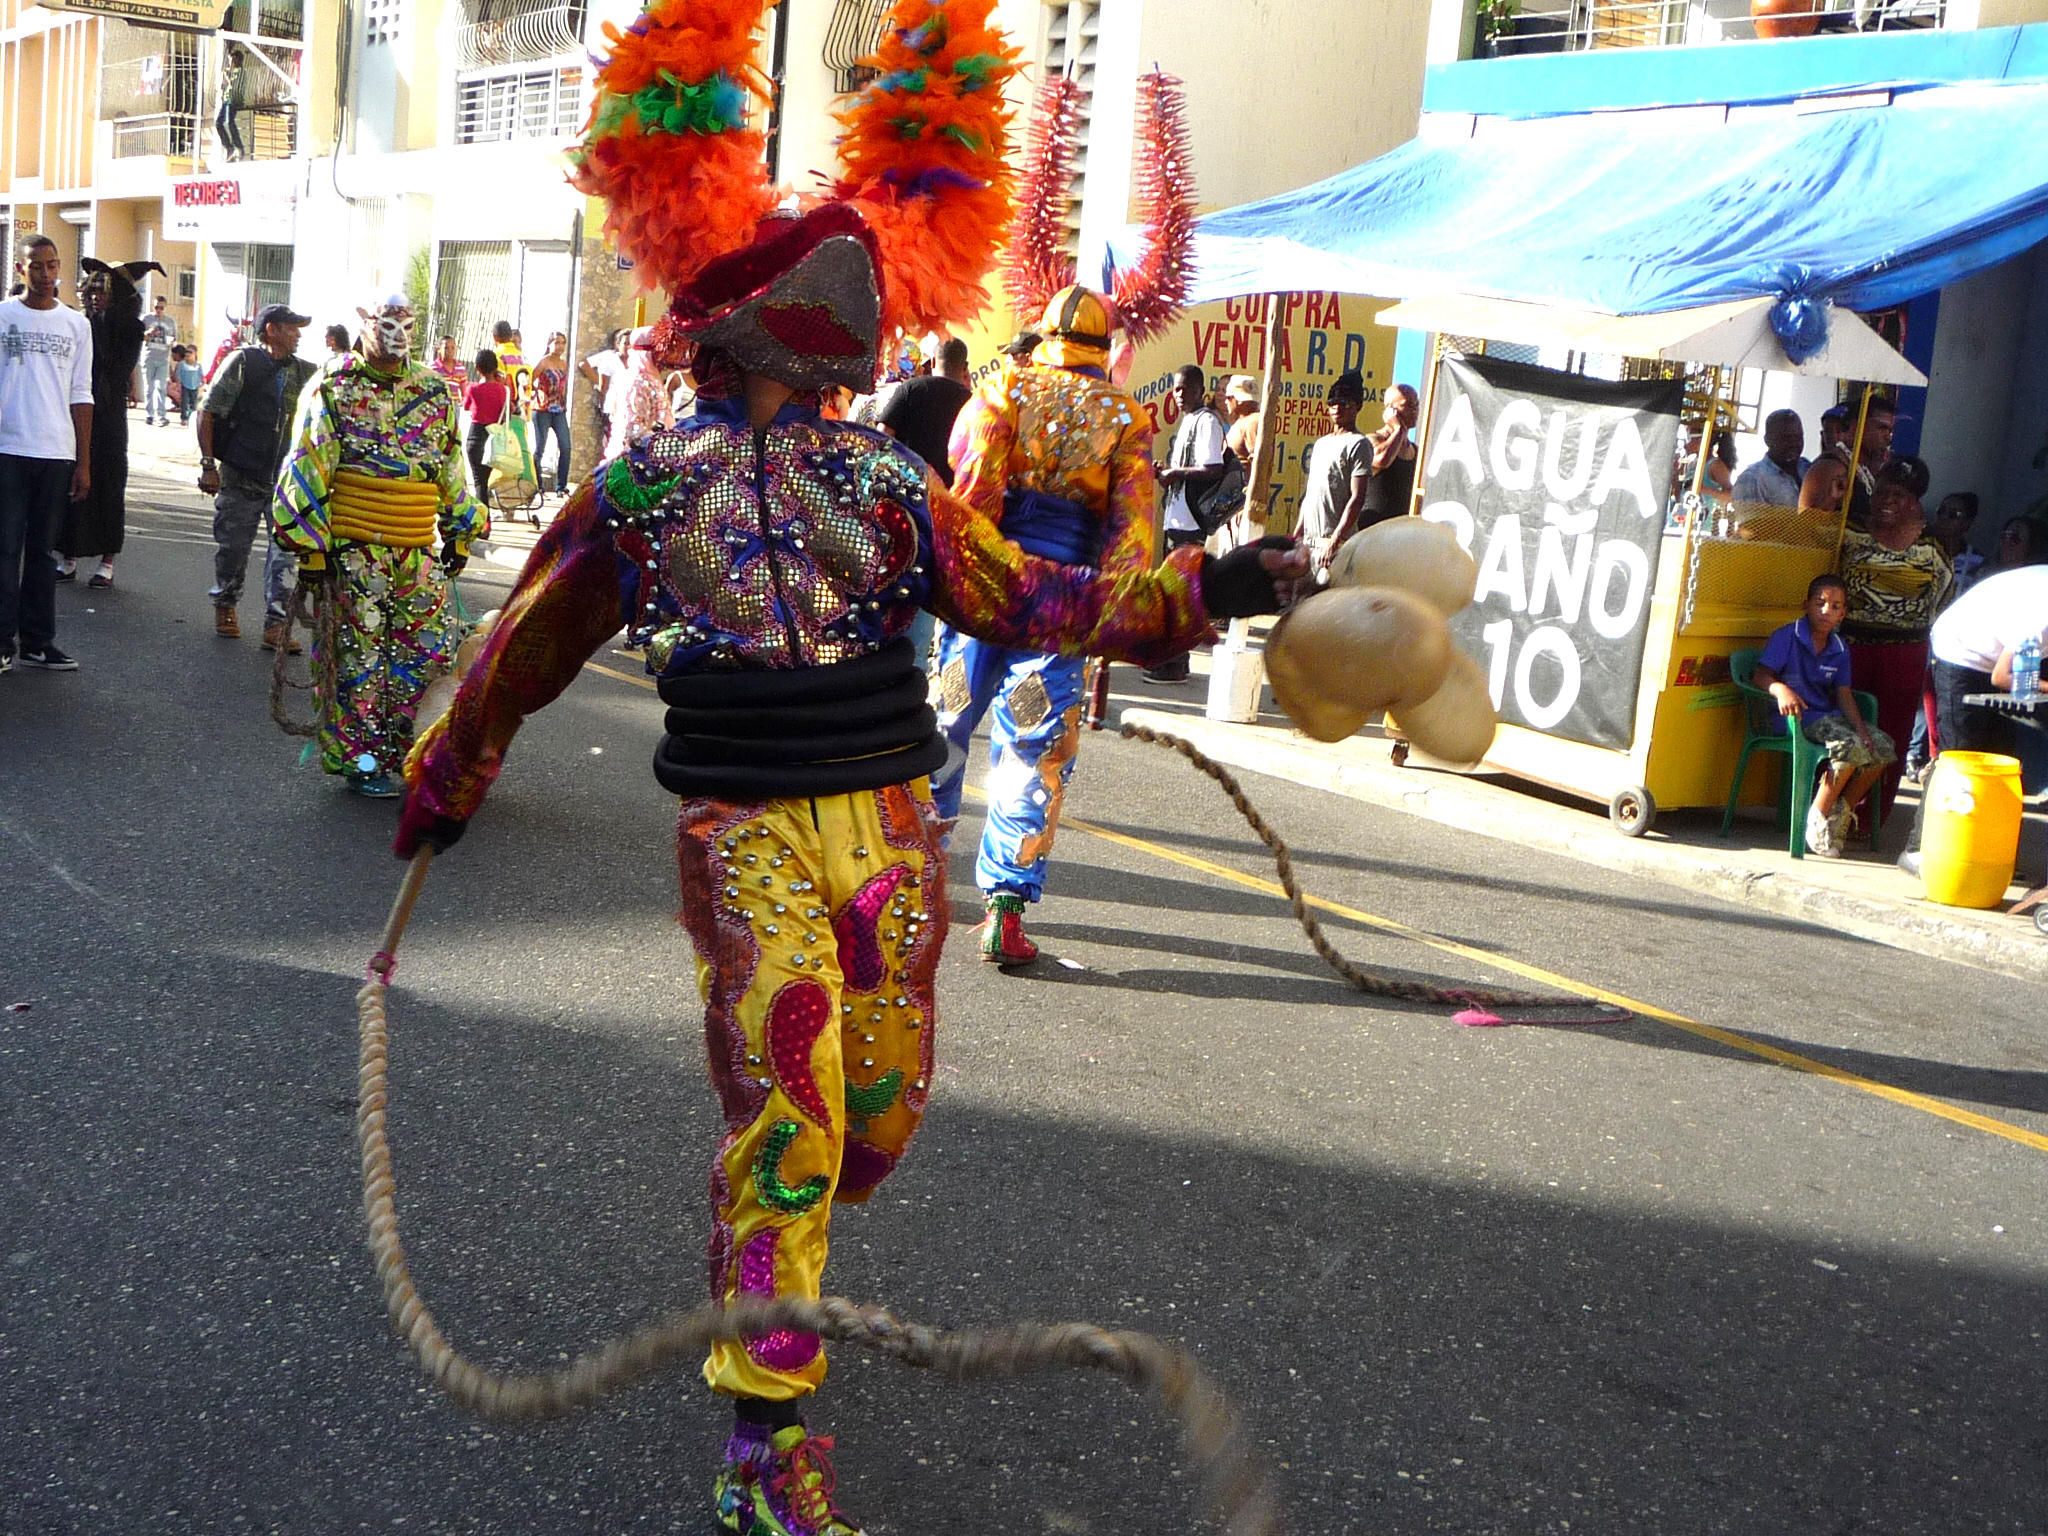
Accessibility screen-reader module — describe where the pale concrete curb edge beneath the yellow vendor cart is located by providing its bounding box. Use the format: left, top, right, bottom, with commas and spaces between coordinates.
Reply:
1122, 709, 2048, 983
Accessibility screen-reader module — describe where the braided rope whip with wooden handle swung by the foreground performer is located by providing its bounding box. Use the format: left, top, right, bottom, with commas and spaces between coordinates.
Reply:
356, 848, 1280, 1536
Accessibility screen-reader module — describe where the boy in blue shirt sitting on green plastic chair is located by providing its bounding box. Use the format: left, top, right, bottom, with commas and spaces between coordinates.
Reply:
1755, 575, 1898, 858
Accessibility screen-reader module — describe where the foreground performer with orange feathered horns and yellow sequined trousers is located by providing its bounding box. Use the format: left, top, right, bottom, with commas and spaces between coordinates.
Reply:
395, 0, 1300, 1536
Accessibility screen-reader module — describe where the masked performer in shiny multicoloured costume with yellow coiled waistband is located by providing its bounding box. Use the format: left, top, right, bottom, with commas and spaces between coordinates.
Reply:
276, 295, 489, 797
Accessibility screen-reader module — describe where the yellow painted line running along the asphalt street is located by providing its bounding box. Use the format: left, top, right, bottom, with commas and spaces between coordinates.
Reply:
584, 662, 2048, 1151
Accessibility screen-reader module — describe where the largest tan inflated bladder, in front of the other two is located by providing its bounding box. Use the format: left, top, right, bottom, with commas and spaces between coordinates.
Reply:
1266, 586, 1454, 741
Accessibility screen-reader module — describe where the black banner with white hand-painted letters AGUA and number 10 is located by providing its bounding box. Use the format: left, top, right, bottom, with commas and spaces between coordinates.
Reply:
1421, 356, 1683, 750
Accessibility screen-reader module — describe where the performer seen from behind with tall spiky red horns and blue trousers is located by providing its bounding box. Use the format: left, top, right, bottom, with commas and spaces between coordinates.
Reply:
932, 70, 1194, 965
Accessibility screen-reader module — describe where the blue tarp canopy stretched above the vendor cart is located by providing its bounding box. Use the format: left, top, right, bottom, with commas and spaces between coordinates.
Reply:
1112, 82, 2048, 321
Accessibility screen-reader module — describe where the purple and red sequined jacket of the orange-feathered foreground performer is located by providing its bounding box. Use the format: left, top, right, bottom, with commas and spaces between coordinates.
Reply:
406, 401, 1208, 819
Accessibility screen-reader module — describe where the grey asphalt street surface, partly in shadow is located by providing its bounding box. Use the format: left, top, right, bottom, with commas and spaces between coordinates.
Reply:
0, 481, 2048, 1536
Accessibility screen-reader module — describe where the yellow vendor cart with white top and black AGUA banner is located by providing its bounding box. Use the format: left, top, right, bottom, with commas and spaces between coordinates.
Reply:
1378, 295, 1925, 836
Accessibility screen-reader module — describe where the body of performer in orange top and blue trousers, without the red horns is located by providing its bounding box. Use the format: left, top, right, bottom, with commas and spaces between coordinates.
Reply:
932, 287, 1155, 965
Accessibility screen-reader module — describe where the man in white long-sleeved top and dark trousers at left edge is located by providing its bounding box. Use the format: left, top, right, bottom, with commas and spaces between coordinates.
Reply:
0, 236, 92, 672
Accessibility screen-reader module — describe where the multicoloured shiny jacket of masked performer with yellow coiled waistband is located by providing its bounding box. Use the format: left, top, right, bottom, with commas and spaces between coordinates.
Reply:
274, 352, 489, 567
